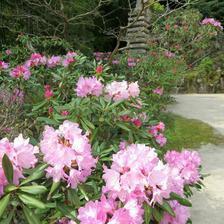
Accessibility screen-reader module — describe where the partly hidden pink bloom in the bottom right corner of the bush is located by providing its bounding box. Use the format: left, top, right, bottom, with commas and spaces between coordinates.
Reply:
160, 201, 190, 224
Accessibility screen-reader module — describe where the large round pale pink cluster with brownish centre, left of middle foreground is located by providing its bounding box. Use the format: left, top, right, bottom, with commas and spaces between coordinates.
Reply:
40, 121, 97, 188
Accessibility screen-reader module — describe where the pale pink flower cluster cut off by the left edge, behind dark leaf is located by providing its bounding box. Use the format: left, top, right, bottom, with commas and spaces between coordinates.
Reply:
0, 134, 39, 195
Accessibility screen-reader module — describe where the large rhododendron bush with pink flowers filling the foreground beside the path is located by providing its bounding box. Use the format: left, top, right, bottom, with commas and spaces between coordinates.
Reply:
0, 46, 203, 224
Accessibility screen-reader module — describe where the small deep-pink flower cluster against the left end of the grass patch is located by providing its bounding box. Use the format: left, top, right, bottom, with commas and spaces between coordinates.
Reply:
149, 122, 167, 147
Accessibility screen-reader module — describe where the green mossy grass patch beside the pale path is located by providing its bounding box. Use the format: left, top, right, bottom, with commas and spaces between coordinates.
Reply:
164, 113, 224, 150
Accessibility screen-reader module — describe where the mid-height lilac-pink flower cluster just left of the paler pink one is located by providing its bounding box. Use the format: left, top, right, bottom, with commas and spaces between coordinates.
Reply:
75, 76, 103, 97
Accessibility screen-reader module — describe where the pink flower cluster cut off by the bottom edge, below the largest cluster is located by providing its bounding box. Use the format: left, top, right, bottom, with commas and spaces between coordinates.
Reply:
78, 195, 143, 224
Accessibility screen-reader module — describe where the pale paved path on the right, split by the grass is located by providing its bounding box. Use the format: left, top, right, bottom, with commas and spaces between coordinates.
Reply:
169, 94, 224, 224
